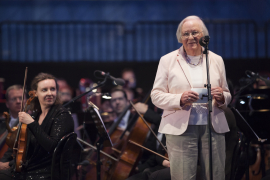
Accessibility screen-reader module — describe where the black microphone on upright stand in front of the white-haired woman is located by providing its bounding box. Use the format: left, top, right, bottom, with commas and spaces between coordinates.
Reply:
203, 38, 213, 180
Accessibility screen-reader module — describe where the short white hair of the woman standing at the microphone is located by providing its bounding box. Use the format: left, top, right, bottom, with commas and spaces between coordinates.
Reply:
176, 16, 209, 43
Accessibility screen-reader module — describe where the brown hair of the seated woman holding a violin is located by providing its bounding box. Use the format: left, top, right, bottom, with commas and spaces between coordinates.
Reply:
30, 73, 61, 112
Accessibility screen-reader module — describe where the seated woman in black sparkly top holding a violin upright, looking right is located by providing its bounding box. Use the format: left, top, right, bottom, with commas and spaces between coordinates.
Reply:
0, 73, 74, 180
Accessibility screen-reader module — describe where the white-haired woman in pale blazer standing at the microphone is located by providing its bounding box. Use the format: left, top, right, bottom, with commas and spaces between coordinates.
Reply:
151, 16, 231, 180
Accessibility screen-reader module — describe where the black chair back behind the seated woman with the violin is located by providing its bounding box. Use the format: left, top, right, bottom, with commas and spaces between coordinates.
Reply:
51, 132, 77, 180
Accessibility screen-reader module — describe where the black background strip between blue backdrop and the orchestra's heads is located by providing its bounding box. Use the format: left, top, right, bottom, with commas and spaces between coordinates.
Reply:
0, 59, 270, 91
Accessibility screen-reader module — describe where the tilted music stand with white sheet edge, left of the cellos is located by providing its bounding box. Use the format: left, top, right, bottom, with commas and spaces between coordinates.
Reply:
88, 106, 112, 180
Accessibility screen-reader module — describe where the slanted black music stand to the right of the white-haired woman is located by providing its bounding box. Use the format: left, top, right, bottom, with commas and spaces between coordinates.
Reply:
231, 108, 267, 180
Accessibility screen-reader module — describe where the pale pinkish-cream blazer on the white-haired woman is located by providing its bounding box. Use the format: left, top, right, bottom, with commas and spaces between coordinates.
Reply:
151, 46, 231, 135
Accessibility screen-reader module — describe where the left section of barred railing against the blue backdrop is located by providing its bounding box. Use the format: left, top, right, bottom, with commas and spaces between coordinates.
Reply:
0, 21, 124, 62
